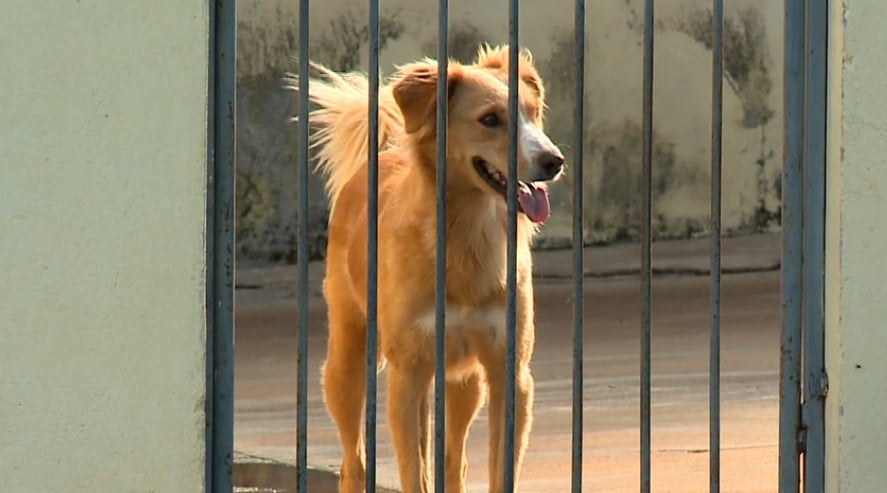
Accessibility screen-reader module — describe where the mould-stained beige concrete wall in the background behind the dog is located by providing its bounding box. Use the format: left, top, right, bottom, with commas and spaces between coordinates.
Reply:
237, 0, 784, 260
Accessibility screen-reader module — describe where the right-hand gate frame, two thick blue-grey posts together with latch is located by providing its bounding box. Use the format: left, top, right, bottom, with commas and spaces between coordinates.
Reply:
779, 0, 830, 493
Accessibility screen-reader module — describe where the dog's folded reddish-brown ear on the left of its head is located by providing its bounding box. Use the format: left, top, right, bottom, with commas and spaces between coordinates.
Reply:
392, 62, 461, 134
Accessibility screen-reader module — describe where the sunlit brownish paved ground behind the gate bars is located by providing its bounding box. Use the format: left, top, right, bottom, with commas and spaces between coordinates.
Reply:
235, 234, 779, 493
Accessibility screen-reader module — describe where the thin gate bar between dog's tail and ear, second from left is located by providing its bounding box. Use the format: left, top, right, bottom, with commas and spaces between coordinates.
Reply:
366, 0, 379, 493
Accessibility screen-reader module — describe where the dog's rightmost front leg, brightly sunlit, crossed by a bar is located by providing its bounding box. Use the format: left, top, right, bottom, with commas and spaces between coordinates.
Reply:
487, 361, 534, 493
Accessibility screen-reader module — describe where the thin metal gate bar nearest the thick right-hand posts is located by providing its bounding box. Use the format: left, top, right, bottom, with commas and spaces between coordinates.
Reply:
708, 0, 724, 493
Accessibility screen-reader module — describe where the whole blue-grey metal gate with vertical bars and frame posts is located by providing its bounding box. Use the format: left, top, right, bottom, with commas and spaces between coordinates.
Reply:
206, 0, 828, 493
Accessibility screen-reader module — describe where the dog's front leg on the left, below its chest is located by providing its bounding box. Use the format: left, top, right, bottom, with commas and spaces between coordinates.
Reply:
388, 364, 431, 493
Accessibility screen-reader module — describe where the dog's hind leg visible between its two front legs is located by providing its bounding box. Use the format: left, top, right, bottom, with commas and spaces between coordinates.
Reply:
446, 372, 484, 493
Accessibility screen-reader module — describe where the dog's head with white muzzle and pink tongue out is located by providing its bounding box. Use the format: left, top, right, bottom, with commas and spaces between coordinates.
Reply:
393, 47, 564, 223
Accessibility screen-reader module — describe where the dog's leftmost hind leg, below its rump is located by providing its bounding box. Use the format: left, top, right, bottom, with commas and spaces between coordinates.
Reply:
323, 284, 366, 493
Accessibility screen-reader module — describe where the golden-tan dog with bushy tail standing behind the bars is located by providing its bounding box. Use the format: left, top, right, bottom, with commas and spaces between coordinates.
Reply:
290, 46, 565, 493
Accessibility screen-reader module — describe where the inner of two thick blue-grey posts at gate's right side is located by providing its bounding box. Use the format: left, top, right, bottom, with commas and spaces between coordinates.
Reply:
779, 0, 806, 493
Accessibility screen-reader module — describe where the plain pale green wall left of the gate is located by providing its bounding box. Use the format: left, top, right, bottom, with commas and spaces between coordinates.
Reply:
0, 0, 208, 493
